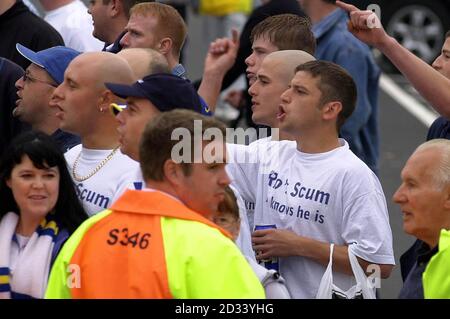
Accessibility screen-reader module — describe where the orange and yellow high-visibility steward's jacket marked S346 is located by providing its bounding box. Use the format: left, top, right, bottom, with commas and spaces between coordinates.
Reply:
46, 190, 265, 299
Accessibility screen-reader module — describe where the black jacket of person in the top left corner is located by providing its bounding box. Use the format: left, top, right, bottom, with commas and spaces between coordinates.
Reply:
0, 0, 64, 70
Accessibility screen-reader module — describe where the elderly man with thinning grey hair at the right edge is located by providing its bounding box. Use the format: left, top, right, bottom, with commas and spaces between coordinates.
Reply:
393, 139, 450, 299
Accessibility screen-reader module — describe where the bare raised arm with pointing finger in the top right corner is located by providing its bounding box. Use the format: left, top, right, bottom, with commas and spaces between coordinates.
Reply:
336, 1, 450, 118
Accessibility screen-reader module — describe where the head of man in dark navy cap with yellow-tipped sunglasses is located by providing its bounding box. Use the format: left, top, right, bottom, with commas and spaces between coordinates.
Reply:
105, 73, 202, 161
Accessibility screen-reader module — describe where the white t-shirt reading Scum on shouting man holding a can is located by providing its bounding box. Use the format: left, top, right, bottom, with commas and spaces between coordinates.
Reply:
228, 139, 395, 298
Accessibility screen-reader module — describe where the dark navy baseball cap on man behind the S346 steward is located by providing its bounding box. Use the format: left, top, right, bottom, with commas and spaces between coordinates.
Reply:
105, 73, 202, 113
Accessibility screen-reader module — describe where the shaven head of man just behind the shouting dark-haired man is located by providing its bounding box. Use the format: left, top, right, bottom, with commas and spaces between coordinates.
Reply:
248, 50, 315, 139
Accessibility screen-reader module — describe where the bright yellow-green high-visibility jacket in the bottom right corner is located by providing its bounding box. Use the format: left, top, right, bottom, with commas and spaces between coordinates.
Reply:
422, 229, 450, 299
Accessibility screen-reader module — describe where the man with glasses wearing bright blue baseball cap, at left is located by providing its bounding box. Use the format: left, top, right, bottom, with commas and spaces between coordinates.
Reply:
13, 43, 80, 152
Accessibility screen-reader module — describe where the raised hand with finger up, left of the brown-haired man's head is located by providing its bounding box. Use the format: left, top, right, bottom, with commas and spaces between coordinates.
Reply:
204, 29, 239, 76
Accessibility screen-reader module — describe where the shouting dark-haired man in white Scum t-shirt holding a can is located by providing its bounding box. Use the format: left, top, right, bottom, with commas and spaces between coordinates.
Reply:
230, 61, 395, 298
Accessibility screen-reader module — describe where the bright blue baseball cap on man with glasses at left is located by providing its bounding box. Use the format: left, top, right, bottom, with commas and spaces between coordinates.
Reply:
16, 43, 81, 85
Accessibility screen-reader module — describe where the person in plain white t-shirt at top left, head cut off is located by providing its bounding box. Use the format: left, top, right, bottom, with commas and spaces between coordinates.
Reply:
39, 0, 103, 52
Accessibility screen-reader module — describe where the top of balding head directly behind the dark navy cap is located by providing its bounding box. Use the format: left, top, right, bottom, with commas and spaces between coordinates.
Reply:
117, 48, 171, 80
